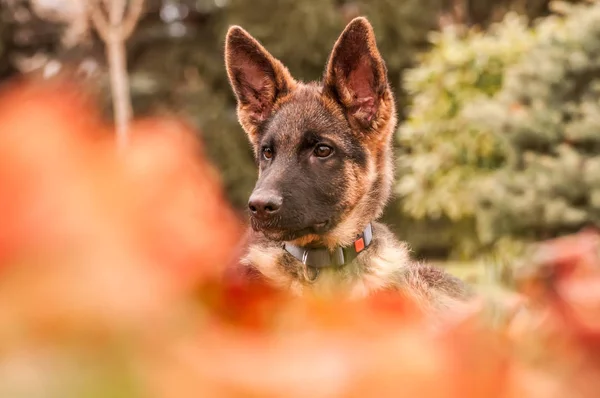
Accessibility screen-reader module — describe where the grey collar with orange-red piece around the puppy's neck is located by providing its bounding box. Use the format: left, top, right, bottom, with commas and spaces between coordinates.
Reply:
283, 223, 373, 268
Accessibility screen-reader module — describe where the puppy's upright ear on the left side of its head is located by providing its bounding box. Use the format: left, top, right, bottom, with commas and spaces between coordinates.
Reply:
225, 26, 296, 143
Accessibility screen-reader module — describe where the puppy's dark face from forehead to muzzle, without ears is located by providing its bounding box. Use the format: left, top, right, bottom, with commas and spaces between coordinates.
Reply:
249, 93, 366, 240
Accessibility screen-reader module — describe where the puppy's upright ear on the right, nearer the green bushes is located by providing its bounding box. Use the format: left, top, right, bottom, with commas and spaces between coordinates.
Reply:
324, 17, 388, 128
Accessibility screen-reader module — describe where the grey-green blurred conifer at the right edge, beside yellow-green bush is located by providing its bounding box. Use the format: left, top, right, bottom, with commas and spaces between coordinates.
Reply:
468, 3, 600, 244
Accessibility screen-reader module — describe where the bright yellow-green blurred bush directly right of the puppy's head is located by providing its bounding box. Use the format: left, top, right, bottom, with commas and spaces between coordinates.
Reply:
396, 13, 534, 256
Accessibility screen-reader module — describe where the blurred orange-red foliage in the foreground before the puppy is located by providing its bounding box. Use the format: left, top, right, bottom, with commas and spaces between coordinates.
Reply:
0, 81, 600, 398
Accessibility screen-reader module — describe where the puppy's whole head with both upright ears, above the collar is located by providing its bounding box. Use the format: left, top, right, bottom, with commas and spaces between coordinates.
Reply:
225, 18, 396, 246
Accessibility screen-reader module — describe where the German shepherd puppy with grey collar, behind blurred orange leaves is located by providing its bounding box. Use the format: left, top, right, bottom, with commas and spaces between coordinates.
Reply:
225, 17, 470, 308
